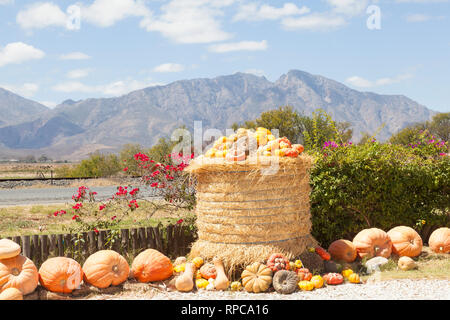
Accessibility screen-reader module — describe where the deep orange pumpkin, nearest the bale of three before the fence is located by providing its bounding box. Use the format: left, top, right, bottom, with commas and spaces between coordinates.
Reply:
131, 249, 173, 282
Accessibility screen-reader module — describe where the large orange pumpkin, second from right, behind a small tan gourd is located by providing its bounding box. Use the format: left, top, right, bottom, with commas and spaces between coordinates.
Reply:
387, 226, 423, 257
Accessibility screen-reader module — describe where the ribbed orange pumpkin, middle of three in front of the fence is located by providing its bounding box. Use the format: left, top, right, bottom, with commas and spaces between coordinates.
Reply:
83, 250, 130, 288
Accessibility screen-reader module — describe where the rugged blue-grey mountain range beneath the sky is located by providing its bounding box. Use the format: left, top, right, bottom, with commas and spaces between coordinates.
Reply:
0, 70, 435, 160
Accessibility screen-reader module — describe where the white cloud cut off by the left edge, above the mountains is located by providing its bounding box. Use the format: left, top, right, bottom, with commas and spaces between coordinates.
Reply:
0, 42, 45, 67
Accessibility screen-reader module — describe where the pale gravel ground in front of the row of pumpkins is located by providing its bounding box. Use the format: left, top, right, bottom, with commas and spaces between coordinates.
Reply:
89, 279, 450, 300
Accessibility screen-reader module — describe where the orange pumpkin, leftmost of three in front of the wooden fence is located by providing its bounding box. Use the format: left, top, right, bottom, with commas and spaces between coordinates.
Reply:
39, 257, 83, 293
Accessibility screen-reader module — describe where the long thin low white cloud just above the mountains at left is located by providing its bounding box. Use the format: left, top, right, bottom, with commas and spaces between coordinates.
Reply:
52, 79, 162, 96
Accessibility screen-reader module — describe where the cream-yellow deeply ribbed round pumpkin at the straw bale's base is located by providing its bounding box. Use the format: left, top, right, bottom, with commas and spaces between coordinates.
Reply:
241, 262, 273, 293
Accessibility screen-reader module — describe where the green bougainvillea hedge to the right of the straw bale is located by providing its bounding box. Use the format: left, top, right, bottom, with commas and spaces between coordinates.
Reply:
311, 132, 450, 245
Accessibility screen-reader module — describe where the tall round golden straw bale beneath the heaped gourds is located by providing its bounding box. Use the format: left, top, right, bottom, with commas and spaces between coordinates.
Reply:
187, 155, 316, 273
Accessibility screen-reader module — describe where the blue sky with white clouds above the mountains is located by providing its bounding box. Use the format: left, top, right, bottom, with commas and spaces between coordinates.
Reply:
0, 0, 450, 112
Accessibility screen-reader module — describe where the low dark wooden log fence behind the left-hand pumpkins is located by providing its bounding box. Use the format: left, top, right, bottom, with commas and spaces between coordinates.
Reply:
3, 225, 197, 268
